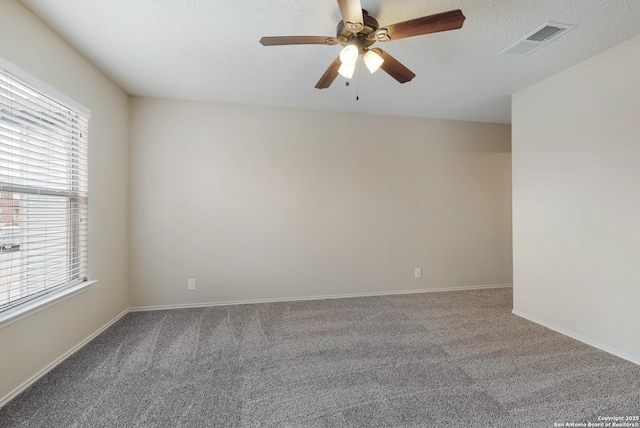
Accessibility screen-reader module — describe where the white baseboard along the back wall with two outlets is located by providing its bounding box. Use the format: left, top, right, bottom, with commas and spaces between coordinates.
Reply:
129, 284, 513, 312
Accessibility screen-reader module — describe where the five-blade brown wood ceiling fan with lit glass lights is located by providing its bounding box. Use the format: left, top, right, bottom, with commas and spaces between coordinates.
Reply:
260, 0, 465, 89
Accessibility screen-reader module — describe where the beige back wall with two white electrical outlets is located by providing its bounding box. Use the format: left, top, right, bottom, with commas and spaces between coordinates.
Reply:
130, 98, 512, 306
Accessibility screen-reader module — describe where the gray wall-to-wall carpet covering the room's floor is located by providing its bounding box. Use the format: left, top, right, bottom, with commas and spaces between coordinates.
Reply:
0, 289, 640, 427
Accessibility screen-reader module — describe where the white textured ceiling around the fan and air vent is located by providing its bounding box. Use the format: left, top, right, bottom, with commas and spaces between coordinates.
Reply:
22, 0, 640, 123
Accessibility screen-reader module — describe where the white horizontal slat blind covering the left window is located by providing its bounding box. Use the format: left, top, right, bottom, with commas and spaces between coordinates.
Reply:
0, 68, 88, 312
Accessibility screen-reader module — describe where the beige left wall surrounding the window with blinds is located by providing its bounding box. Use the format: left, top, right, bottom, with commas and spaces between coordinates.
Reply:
0, 0, 129, 400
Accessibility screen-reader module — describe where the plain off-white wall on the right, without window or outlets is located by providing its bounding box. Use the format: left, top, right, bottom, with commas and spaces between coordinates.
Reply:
513, 33, 640, 363
